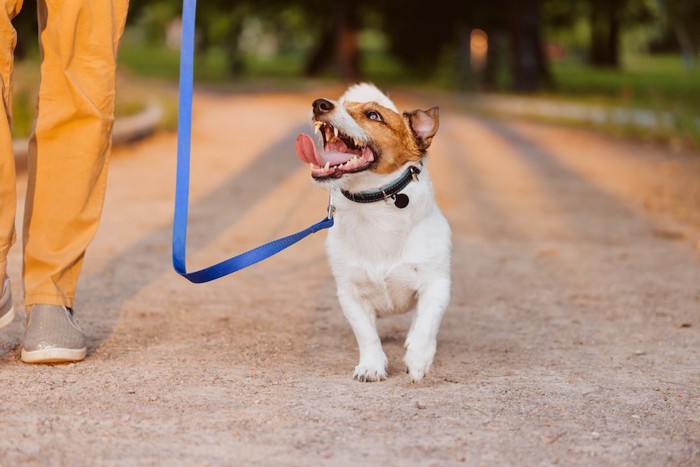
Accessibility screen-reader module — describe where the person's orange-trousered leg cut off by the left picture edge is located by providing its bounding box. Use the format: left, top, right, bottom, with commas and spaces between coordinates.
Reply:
0, 0, 22, 328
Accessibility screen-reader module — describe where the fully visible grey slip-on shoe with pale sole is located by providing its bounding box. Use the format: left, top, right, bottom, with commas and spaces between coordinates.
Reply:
22, 305, 86, 363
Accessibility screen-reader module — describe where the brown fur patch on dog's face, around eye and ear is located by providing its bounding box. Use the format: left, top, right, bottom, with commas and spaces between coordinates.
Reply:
345, 102, 438, 174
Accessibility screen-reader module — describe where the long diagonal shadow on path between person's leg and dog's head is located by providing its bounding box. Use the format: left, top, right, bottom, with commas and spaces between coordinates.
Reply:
80, 126, 306, 349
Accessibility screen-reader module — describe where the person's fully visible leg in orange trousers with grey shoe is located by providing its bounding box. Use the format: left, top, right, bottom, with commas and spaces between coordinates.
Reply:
22, 0, 128, 363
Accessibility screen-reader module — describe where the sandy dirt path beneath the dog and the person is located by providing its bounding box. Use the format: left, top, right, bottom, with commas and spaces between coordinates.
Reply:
0, 85, 700, 466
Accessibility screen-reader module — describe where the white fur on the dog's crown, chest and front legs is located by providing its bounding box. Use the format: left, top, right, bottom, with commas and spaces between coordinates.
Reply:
325, 84, 451, 381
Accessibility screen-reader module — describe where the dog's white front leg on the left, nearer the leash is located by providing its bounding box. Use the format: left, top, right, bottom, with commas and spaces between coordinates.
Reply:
338, 287, 388, 382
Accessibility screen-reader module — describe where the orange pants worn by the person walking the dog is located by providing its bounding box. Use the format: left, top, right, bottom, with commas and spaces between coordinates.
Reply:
0, 0, 128, 307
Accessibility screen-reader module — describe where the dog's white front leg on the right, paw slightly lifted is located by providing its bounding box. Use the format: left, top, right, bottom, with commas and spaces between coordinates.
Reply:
404, 277, 450, 382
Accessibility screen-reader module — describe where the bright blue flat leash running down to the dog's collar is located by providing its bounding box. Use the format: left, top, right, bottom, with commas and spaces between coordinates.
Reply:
173, 0, 333, 284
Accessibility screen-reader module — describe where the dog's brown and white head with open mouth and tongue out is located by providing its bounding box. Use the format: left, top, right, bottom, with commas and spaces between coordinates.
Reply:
296, 83, 439, 187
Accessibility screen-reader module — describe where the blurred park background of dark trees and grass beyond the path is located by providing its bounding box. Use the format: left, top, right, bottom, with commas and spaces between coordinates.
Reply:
13, 0, 700, 148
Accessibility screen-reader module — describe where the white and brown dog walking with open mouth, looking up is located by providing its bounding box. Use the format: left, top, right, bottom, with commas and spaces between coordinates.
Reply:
296, 83, 451, 382
